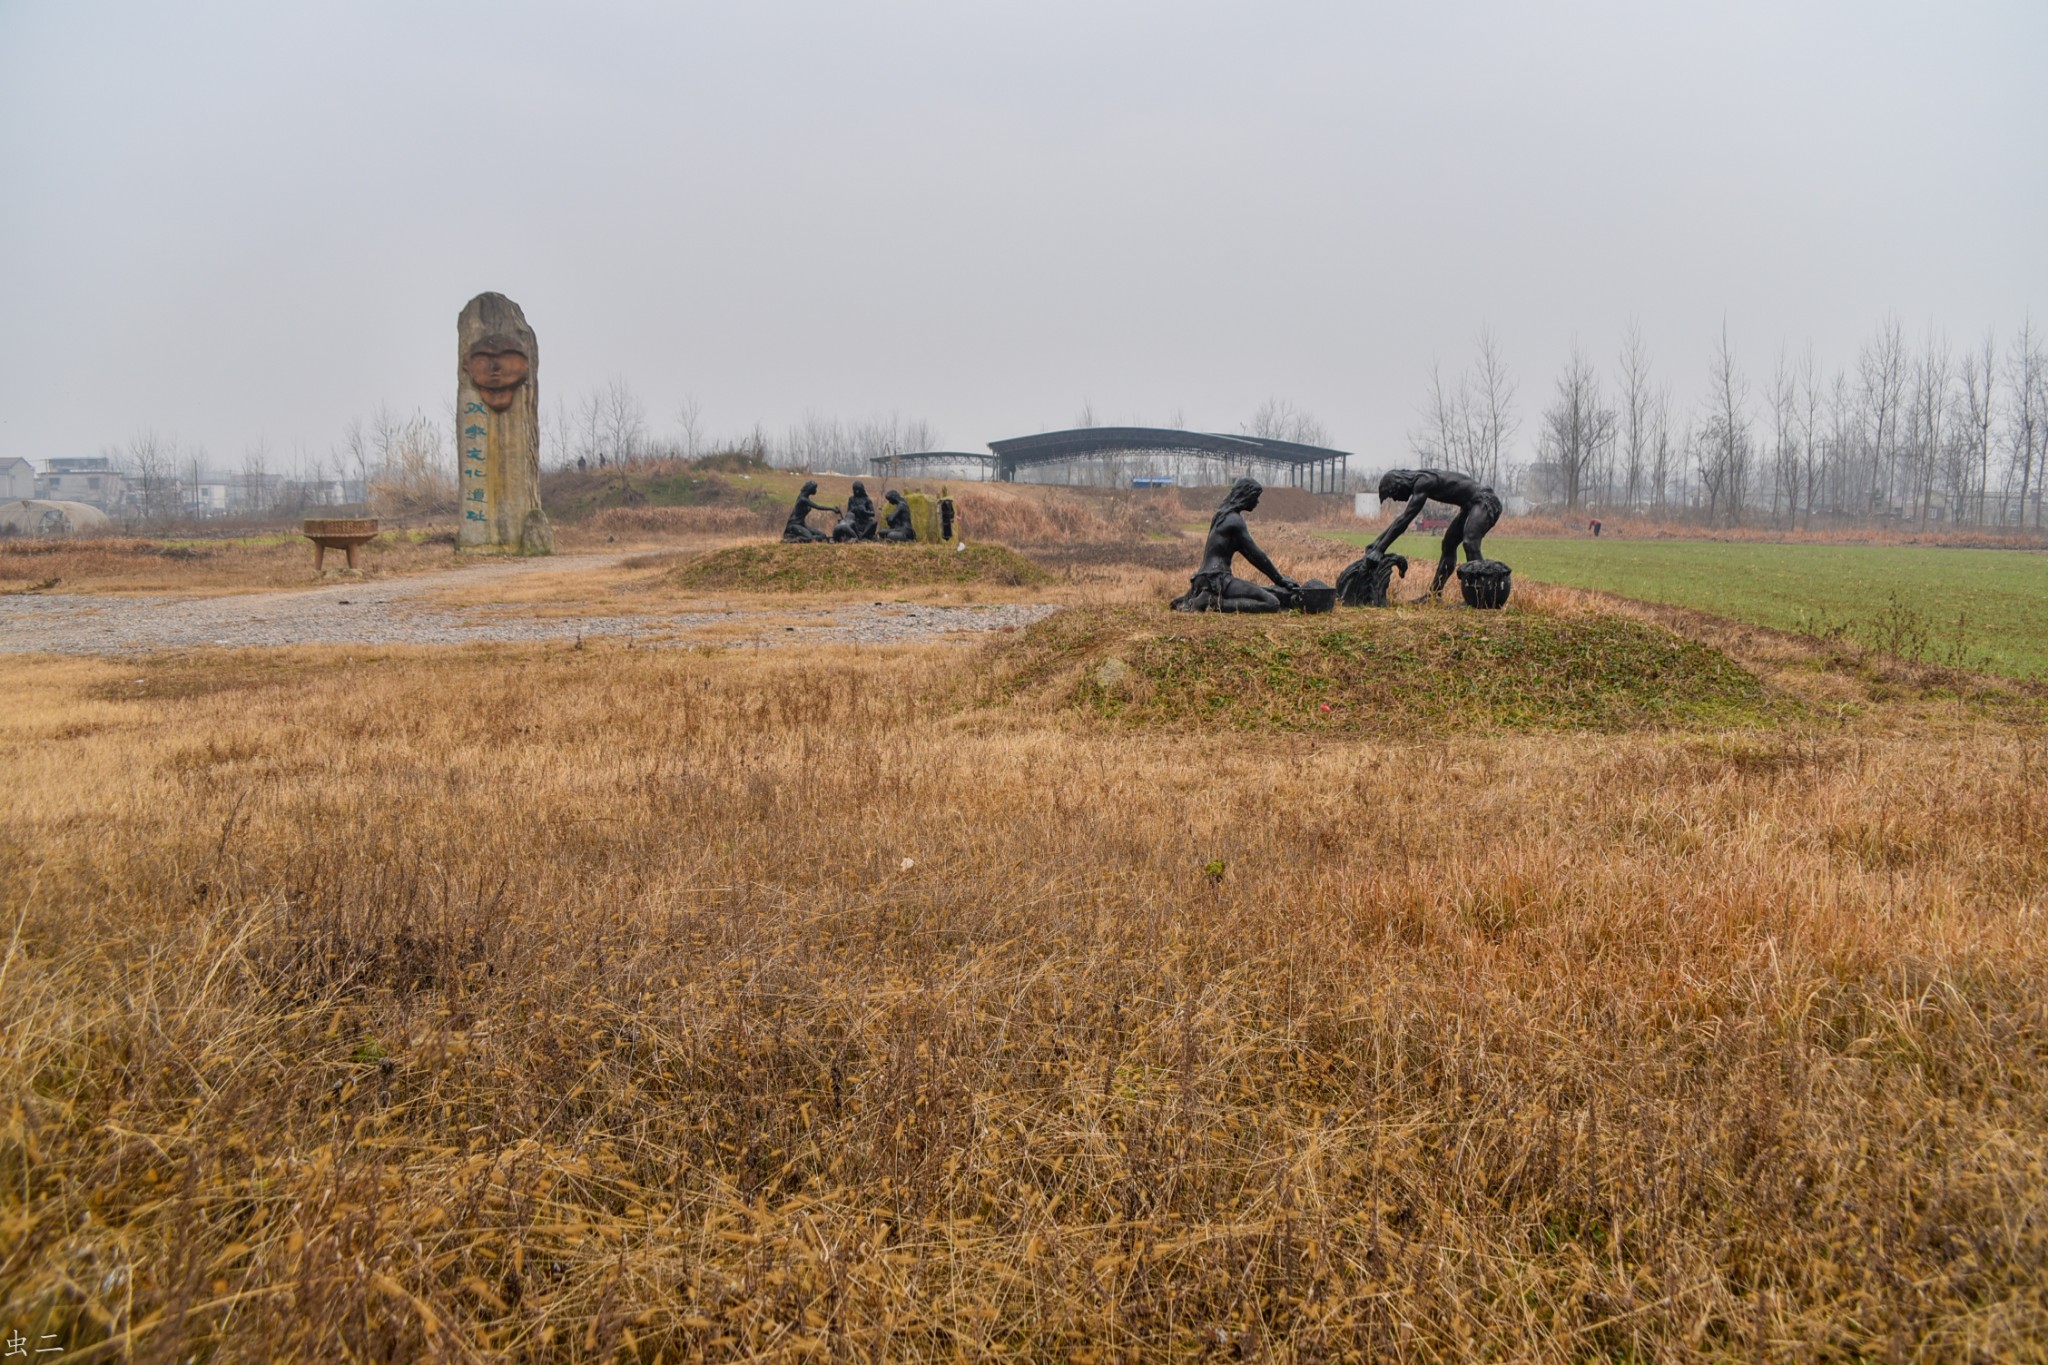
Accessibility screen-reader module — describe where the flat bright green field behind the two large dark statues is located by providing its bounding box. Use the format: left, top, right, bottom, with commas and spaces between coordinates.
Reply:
1337, 532, 2048, 677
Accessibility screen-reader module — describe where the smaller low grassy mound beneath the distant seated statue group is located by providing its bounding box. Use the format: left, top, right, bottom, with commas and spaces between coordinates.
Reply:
672, 542, 1051, 593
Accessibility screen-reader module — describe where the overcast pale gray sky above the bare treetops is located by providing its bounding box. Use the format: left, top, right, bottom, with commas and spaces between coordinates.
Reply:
0, 0, 2048, 467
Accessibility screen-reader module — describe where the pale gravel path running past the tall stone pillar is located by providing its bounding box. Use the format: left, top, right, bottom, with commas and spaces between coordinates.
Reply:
0, 555, 1053, 655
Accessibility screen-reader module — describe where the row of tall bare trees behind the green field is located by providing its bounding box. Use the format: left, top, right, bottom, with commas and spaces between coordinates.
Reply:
1499, 319, 2048, 530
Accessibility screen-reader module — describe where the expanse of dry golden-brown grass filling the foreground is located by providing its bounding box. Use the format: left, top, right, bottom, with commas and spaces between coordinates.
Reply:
0, 626, 2048, 1361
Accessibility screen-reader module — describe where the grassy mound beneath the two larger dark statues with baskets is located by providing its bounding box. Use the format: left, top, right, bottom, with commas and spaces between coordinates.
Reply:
995, 608, 1786, 733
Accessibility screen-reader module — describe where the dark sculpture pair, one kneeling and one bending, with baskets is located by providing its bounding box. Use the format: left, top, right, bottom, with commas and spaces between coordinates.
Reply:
1174, 469, 1509, 612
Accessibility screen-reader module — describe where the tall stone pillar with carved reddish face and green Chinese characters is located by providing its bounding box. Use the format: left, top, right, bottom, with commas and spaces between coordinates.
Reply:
455, 295, 555, 555
